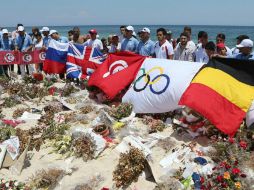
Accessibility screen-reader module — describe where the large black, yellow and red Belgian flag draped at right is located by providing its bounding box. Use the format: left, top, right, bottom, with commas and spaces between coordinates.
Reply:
179, 58, 254, 136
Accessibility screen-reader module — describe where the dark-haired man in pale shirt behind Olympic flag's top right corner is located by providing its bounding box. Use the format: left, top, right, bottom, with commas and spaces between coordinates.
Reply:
195, 31, 209, 63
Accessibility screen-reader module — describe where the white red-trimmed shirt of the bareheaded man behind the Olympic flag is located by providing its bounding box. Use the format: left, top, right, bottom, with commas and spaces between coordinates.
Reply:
154, 40, 174, 59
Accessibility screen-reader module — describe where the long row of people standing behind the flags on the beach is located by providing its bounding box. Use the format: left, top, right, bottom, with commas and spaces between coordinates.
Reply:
0, 24, 254, 76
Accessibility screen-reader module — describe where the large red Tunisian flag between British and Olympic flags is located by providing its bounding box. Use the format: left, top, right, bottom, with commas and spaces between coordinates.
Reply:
88, 52, 146, 99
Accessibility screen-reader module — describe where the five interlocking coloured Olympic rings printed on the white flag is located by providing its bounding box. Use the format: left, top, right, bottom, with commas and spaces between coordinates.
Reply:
133, 67, 170, 95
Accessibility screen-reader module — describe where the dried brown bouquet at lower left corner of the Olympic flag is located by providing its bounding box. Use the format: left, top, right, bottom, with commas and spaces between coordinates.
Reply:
109, 103, 132, 120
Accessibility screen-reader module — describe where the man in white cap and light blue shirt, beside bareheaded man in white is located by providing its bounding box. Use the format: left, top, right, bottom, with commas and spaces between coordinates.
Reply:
137, 28, 155, 56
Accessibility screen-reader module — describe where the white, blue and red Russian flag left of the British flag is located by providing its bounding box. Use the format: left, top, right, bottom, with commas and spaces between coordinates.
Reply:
43, 39, 69, 74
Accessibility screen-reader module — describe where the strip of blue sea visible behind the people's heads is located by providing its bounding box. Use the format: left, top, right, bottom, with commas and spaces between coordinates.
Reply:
3, 25, 254, 48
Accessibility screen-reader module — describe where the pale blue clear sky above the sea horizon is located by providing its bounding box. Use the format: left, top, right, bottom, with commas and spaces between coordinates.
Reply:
0, 0, 254, 26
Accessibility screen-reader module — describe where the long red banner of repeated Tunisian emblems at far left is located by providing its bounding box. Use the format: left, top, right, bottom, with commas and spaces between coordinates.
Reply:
0, 50, 46, 65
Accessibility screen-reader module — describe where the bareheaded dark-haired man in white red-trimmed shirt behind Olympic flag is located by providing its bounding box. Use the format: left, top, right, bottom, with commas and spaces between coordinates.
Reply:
154, 28, 174, 59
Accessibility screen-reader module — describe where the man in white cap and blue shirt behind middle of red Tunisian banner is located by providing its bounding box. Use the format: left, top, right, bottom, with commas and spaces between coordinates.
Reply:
15, 26, 34, 77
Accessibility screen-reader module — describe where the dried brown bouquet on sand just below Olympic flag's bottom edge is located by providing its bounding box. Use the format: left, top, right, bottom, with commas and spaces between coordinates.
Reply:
143, 116, 165, 133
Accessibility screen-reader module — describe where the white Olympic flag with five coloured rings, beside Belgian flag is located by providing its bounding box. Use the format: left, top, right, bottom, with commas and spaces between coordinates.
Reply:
122, 58, 203, 113
